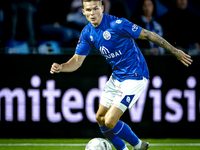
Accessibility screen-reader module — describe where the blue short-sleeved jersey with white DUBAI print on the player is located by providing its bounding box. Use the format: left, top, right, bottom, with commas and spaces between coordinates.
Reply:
75, 14, 149, 82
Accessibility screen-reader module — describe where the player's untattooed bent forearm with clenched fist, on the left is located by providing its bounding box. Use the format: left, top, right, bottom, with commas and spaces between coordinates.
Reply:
50, 54, 86, 74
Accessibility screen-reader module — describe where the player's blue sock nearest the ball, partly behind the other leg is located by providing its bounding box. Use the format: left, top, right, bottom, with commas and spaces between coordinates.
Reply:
100, 125, 126, 150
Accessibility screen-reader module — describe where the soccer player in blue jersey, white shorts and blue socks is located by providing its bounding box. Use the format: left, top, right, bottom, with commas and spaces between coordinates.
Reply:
50, 0, 192, 150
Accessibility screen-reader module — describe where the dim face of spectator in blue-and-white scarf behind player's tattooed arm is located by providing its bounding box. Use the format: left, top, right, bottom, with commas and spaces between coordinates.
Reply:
142, 0, 154, 17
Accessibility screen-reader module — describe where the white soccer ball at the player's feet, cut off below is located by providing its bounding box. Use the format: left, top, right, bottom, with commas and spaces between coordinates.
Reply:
85, 138, 112, 150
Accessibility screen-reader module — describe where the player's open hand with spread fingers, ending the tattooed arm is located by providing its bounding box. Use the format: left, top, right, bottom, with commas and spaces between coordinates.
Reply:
176, 50, 193, 67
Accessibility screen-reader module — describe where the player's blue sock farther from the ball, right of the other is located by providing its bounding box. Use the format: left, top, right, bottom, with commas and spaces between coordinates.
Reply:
112, 120, 139, 146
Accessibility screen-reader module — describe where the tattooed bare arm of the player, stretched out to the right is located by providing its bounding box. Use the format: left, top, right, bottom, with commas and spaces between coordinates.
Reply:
138, 28, 192, 67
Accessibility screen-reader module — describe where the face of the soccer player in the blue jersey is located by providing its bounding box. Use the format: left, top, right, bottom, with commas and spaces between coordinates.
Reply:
82, 1, 104, 27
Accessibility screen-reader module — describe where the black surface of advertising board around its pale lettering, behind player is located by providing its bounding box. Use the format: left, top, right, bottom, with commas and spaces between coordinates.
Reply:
0, 55, 200, 138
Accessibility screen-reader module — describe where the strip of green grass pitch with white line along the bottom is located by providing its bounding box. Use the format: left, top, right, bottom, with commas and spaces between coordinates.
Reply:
0, 139, 200, 150
